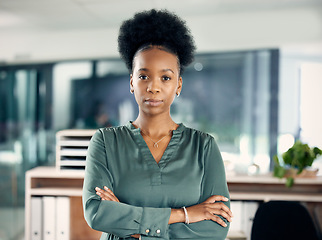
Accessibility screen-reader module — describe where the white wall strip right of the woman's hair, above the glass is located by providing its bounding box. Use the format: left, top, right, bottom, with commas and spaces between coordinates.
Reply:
190, 8, 322, 51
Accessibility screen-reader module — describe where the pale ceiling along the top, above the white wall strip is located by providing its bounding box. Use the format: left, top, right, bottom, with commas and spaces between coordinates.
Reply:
0, 0, 322, 32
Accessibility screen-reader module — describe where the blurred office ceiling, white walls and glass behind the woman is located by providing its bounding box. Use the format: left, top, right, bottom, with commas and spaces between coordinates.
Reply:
0, 0, 322, 240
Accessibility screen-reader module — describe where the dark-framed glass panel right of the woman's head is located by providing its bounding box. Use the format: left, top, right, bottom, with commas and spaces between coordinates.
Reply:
180, 50, 278, 174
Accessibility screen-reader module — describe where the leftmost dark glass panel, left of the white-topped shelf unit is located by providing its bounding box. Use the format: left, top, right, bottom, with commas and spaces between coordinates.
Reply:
0, 65, 54, 239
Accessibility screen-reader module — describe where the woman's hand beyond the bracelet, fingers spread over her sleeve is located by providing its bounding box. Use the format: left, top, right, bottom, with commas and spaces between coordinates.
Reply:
186, 195, 233, 227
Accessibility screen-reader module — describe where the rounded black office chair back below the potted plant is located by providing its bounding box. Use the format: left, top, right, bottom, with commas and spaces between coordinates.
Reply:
251, 201, 319, 240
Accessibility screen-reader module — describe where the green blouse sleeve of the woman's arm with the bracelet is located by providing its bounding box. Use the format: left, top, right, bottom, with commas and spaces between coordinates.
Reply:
170, 137, 230, 240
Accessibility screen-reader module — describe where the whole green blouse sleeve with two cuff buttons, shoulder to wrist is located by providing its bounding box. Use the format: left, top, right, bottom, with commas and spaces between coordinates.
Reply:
83, 130, 171, 239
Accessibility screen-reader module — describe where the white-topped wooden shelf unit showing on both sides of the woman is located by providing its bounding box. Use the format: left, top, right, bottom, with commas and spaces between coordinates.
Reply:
25, 167, 322, 240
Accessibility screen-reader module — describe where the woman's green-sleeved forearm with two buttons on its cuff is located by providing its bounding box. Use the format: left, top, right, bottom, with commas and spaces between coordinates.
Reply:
84, 194, 171, 238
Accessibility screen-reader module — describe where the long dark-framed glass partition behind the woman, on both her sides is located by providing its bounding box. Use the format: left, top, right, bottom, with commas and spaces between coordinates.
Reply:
0, 50, 279, 239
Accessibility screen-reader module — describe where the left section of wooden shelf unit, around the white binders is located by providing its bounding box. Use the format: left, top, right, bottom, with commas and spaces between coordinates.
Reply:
25, 167, 101, 240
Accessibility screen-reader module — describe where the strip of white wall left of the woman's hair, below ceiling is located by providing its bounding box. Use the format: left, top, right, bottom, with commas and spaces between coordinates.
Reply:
0, 29, 118, 63
